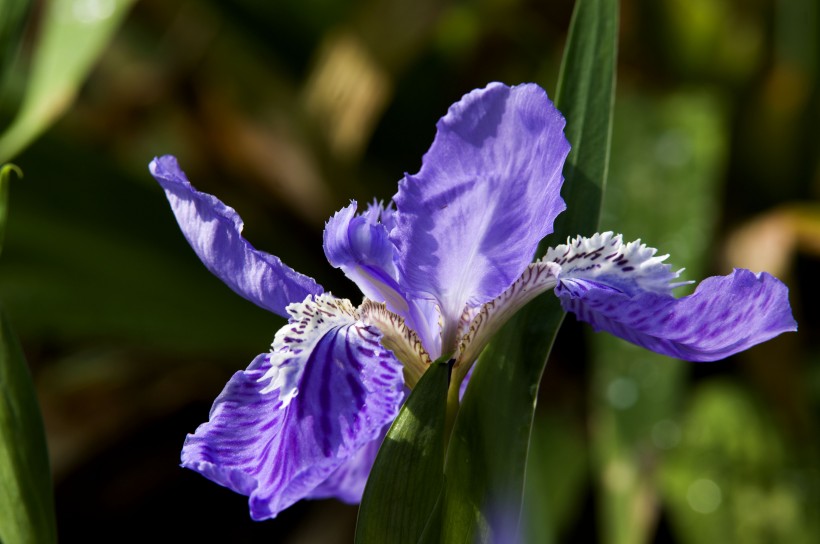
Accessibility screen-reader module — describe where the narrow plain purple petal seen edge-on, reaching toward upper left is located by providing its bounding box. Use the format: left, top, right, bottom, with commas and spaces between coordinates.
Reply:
149, 155, 323, 317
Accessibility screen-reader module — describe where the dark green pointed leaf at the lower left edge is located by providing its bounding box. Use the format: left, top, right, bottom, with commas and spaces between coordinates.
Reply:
0, 314, 57, 544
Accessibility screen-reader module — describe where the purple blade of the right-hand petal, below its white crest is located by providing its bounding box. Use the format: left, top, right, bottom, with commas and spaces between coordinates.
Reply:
555, 269, 797, 361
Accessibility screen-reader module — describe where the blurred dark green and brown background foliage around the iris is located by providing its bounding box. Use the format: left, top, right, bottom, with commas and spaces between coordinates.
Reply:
0, 0, 820, 544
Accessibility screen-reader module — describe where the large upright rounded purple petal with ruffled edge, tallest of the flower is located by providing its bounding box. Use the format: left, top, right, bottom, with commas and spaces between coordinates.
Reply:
391, 83, 569, 341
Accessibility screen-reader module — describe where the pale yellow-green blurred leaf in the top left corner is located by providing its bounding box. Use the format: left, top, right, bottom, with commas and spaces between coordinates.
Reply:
0, 0, 133, 163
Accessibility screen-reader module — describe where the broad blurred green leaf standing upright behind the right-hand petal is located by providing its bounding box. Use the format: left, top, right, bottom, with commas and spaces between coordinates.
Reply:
590, 93, 726, 544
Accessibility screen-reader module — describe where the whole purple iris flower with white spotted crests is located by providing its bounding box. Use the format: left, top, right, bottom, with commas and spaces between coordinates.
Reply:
150, 83, 796, 519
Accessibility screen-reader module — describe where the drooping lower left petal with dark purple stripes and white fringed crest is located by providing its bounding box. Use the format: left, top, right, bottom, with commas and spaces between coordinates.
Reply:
182, 295, 403, 520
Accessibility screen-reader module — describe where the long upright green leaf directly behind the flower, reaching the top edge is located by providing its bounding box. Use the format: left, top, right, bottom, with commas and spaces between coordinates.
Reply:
441, 0, 618, 543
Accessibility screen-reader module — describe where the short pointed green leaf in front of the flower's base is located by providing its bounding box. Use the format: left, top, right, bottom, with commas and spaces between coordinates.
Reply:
356, 359, 450, 544
